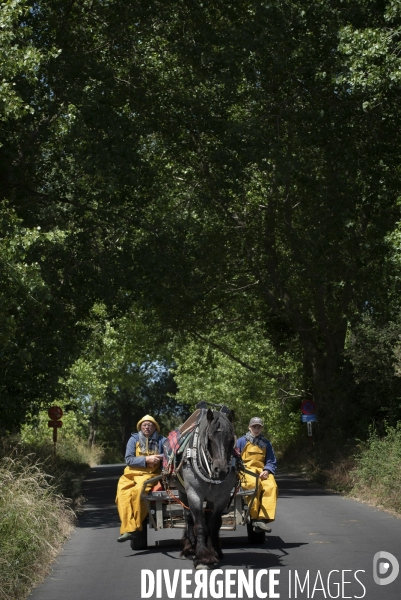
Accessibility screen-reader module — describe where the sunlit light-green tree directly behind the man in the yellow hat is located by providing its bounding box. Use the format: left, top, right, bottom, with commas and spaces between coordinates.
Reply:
64, 305, 188, 453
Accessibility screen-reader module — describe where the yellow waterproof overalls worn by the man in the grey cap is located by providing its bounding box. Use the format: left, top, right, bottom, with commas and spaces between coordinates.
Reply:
241, 442, 277, 521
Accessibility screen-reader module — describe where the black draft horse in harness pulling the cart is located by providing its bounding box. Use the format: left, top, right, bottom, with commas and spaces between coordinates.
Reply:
177, 409, 236, 569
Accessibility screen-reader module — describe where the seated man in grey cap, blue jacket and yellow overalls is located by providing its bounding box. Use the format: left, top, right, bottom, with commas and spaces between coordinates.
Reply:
236, 417, 277, 533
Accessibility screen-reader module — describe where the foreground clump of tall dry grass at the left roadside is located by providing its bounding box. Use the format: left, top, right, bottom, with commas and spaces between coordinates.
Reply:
0, 456, 74, 600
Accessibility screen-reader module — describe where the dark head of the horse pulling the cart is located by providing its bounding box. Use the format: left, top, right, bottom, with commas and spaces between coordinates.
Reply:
205, 409, 235, 479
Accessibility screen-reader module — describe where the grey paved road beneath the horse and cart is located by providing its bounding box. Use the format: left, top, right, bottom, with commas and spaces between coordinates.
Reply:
30, 465, 401, 600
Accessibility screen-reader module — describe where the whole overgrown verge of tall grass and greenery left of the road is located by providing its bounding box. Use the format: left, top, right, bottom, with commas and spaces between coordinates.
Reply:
0, 437, 102, 600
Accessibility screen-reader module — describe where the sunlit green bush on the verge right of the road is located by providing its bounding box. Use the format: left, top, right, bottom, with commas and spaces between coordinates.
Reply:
352, 423, 401, 513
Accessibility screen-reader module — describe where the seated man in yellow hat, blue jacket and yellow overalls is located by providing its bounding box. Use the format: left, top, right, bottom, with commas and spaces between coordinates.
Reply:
116, 415, 166, 542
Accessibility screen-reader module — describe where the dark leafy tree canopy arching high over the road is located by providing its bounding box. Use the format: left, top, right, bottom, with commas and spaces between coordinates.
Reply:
0, 0, 401, 440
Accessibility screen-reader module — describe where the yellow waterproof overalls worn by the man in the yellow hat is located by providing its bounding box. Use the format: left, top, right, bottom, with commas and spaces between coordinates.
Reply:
116, 442, 161, 534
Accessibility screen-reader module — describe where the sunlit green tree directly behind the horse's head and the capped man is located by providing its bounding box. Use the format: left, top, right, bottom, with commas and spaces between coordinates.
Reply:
174, 325, 305, 448
